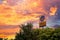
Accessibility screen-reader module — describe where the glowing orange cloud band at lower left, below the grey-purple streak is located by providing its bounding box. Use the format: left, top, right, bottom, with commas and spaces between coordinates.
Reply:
0, 28, 19, 38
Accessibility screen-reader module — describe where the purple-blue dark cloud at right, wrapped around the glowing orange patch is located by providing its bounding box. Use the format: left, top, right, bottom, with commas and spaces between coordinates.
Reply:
43, 0, 60, 26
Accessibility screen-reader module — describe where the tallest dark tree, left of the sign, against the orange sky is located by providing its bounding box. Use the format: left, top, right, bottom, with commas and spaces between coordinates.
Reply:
15, 23, 33, 40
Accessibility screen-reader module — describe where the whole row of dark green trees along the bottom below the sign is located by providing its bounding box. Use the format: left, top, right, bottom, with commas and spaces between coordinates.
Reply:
15, 23, 60, 40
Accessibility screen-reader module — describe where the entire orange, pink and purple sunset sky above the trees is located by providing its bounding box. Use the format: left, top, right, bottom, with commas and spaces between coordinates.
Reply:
0, 0, 60, 38
